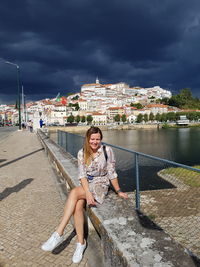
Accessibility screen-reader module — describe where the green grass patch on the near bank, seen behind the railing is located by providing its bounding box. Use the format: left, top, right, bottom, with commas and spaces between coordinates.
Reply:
162, 165, 200, 187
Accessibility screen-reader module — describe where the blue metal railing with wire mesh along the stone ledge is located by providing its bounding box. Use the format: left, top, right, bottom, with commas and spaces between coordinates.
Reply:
57, 131, 200, 257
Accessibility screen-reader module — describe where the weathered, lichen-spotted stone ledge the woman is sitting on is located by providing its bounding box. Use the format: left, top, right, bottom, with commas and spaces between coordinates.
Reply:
38, 131, 196, 267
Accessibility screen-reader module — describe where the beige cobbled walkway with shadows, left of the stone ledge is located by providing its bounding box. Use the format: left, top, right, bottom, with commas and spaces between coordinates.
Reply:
0, 131, 88, 267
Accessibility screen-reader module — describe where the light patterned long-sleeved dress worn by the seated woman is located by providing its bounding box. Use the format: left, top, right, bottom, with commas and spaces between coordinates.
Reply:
78, 145, 117, 204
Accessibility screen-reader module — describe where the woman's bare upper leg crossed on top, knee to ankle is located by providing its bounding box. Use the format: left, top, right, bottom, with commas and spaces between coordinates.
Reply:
56, 186, 86, 235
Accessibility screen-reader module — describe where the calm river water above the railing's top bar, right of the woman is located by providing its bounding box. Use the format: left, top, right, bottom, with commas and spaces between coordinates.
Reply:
103, 128, 200, 165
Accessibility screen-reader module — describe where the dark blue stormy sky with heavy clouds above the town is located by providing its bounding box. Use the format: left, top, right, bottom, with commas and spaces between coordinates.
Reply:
0, 0, 200, 104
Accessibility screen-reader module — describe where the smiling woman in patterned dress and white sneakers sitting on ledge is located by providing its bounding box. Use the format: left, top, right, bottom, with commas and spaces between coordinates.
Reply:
42, 127, 128, 263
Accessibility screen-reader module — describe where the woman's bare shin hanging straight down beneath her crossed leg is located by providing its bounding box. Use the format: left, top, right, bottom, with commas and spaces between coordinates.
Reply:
74, 199, 85, 245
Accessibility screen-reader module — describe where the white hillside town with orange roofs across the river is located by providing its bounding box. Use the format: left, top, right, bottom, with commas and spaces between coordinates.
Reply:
0, 78, 186, 128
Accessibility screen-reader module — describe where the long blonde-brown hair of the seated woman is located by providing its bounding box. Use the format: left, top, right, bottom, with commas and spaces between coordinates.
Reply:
83, 126, 103, 165
